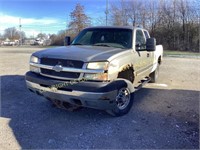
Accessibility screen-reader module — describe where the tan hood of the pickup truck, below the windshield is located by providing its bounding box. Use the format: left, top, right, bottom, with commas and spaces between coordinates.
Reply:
33, 46, 125, 62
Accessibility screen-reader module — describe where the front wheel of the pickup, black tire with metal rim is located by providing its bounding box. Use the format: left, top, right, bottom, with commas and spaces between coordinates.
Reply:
107, 87, 134, 117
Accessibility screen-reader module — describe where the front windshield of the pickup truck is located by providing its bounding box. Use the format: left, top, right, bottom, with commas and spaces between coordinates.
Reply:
72, 28, 132, 49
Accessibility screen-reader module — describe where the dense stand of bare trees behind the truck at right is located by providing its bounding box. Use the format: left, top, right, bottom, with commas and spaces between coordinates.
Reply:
110, 0, 200, 51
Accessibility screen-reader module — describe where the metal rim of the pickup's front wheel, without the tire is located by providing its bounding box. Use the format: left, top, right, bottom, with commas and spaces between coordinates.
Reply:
116, 88, 131, 110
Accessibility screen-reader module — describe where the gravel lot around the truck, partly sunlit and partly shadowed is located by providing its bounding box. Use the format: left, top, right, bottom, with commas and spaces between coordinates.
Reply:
0, 48, 200, 149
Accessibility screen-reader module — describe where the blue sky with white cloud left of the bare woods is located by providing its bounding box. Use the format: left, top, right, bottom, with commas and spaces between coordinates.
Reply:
0, 0, 109, 36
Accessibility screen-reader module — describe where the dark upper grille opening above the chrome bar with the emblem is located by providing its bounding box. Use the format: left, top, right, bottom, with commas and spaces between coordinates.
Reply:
41, 58, 84, 68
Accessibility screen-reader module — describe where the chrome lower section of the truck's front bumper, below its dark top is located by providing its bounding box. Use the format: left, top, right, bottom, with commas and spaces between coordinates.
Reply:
26, 80, 117, 110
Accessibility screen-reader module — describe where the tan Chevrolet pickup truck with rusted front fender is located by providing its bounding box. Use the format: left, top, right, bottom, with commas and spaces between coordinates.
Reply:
26, 26, 163, 116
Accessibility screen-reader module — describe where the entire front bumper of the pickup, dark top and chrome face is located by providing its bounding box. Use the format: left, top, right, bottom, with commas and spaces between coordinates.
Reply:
26, 72, 124, 110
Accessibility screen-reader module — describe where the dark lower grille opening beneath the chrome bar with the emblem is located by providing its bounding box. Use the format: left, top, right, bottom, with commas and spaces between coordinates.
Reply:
41, 68, 80, 78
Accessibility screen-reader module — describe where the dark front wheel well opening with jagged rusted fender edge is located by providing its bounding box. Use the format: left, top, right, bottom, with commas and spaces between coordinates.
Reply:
117, 66, 134, 83
